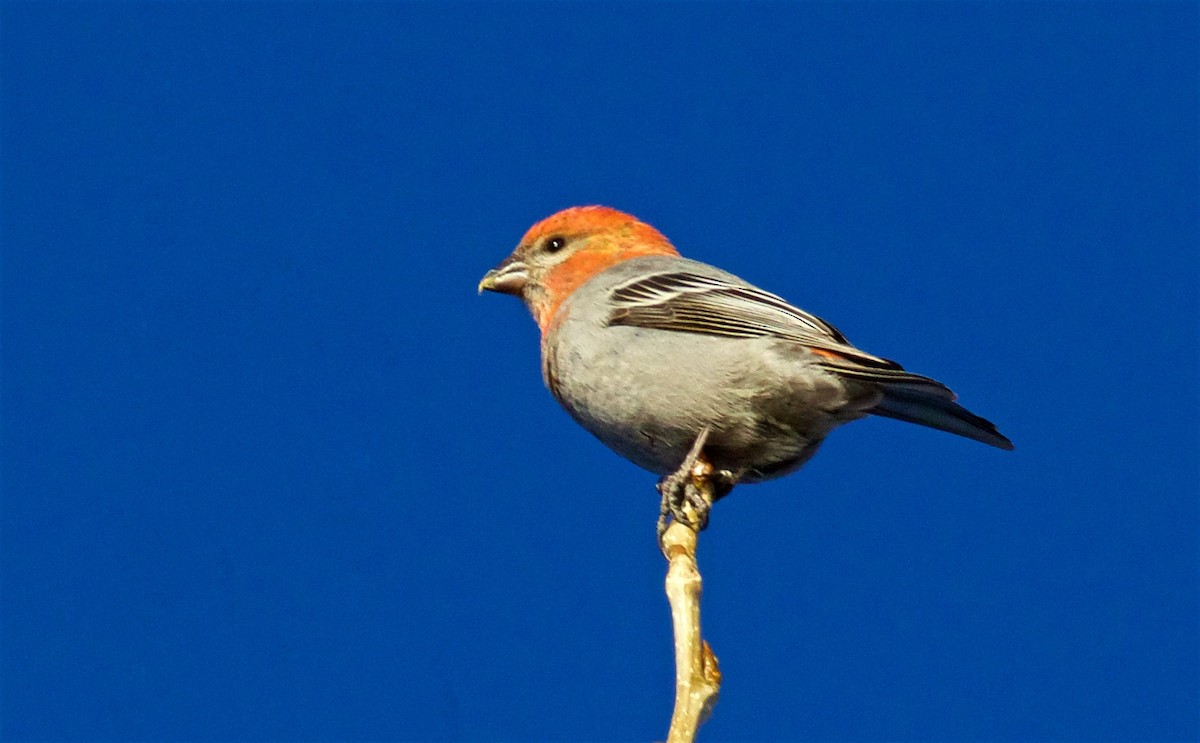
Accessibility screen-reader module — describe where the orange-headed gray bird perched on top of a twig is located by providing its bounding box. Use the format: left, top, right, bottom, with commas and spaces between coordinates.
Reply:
478, 205, 1013, 543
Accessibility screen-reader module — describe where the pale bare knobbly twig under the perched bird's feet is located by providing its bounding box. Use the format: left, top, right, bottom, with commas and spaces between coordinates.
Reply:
661, 457, 721, 743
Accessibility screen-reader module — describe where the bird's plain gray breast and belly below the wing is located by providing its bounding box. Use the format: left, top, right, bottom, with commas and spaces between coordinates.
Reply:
544, 326, 863, 483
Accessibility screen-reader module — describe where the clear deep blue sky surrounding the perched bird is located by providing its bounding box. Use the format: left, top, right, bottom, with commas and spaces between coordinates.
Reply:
0, 1, 1200, 741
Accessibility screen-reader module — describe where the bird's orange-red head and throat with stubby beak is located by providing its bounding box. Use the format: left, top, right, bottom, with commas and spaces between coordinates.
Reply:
479, 206, 679, 334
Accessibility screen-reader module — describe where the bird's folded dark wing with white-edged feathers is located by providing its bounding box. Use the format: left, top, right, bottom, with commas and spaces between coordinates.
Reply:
608, 271, 953, 388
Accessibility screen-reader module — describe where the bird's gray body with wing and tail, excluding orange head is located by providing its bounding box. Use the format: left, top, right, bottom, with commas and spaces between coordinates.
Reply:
542, 256, 1013, 483
